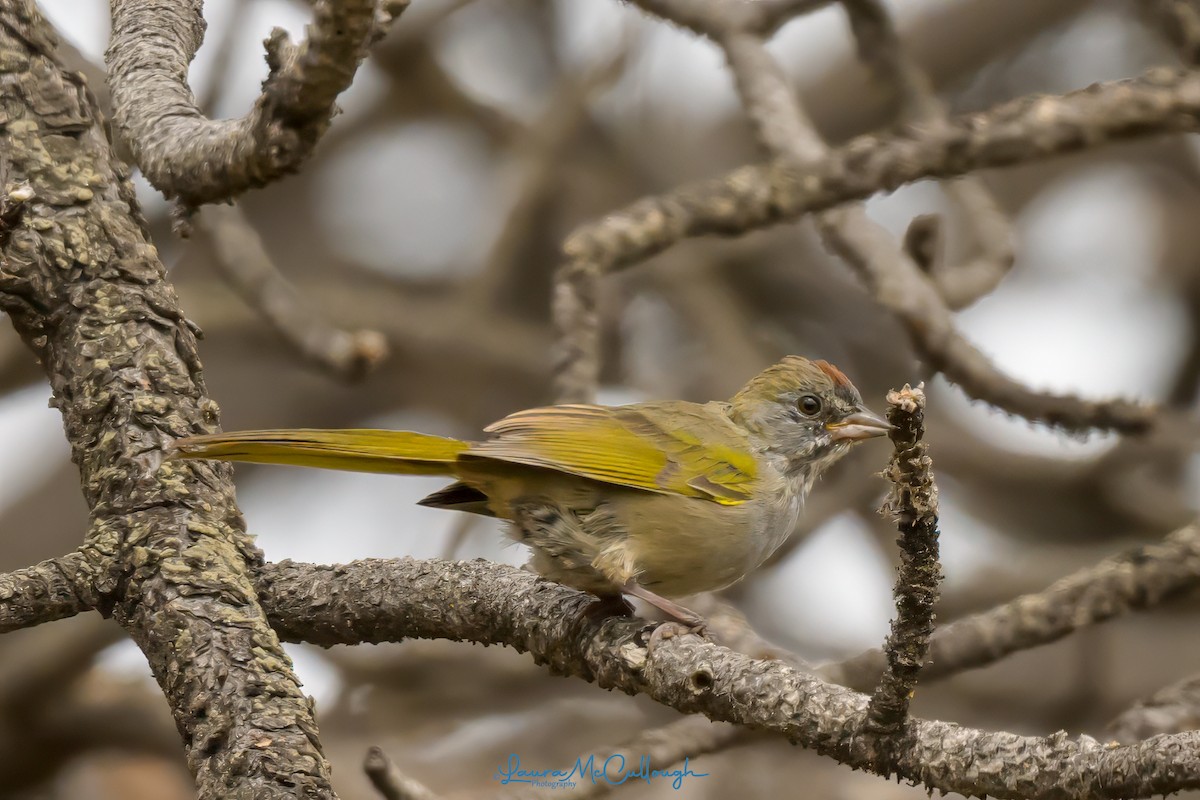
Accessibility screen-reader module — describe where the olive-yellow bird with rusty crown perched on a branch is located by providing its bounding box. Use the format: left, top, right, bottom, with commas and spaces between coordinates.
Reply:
169, 355, 892, 631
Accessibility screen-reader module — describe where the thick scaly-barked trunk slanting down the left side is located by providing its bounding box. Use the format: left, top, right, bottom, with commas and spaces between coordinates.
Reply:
0, 0, 332, 800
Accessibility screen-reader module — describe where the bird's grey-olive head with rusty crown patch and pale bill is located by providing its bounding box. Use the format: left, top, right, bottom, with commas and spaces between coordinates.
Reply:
730, 355, 892, 479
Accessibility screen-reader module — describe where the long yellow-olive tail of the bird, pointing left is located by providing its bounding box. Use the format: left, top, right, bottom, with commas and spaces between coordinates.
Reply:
170, 428, 470, 475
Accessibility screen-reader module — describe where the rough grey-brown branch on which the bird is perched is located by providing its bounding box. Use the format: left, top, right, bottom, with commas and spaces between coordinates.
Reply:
258, 559, 1200, 800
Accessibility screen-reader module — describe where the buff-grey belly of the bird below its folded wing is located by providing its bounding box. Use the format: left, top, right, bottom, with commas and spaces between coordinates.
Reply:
614, 494, 799, 597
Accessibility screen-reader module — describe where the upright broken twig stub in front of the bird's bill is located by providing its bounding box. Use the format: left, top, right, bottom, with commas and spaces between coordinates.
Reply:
865, 386, 942, 736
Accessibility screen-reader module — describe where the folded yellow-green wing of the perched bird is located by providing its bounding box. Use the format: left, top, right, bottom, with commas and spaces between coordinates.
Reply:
463, 403, 757, 505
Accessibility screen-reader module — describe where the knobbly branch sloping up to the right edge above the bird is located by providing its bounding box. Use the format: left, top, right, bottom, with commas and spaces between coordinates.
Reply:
566, 68, 1200, 278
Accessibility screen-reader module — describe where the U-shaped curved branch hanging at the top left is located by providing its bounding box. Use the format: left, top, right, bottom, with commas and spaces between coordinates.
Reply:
106, 0, 403, 207
